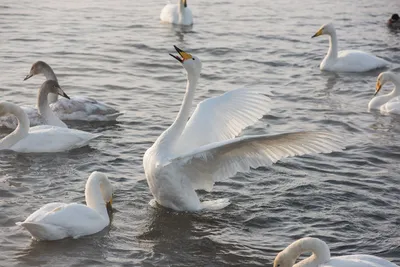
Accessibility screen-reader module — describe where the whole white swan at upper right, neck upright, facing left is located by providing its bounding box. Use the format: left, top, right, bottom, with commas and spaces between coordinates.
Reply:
311, 23, 390, 72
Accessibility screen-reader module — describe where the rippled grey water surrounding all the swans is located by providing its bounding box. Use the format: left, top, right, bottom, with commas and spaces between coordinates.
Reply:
0, 0, 400, 266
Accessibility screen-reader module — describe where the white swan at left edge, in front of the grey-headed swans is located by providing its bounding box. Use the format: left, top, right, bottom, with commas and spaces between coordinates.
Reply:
0, 84, 100, 153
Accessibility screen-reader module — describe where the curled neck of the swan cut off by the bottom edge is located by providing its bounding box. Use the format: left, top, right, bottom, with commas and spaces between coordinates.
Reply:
285, 238, 331, 267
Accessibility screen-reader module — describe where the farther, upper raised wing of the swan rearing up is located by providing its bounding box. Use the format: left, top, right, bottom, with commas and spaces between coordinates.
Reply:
176, 88, 270, 154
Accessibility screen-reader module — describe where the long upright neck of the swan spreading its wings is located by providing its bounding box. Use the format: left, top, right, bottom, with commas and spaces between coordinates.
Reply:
157, 72, 199, 148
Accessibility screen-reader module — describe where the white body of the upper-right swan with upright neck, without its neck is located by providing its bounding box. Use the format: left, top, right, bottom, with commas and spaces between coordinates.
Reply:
328, 50, 389, 72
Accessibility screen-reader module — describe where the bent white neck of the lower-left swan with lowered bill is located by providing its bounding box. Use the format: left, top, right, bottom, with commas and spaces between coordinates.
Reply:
85, 179, 110, 223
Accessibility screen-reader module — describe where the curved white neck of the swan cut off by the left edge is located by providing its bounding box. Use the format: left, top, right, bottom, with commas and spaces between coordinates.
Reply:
0, 106, 30, 150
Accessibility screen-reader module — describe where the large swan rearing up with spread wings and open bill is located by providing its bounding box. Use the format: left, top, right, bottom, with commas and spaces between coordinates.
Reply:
143, 46, 343, 214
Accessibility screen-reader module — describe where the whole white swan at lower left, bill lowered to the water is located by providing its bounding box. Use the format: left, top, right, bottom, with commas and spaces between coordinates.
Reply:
16, 172, 113, 240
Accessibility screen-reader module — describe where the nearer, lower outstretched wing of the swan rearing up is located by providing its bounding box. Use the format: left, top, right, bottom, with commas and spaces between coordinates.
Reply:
169, 132, 344, 191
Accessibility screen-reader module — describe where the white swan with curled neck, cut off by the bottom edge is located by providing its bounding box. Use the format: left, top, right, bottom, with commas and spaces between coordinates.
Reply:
273, 237, 398, 267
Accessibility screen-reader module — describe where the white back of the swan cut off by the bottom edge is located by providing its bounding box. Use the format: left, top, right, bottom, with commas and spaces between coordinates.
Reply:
321, 254, 399, 267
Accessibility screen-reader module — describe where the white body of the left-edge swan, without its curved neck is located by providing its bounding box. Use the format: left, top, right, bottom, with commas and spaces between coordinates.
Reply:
10, 125, 100, 153
